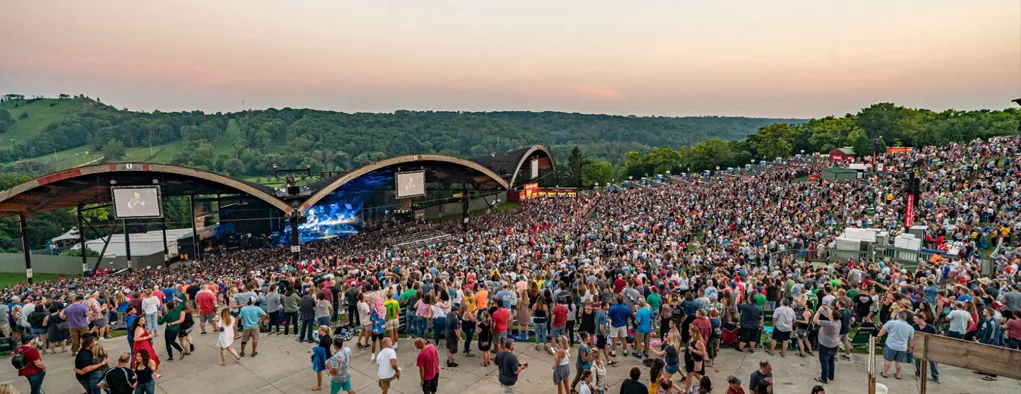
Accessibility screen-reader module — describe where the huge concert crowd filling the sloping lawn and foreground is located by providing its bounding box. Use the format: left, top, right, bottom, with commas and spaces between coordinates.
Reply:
0, 137, 1021, 394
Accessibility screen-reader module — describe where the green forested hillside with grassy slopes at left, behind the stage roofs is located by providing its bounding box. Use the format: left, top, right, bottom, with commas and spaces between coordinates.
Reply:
0, 96, 804, 177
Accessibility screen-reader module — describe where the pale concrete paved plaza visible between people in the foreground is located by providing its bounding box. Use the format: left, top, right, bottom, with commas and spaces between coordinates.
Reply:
0, 333, 1021, 394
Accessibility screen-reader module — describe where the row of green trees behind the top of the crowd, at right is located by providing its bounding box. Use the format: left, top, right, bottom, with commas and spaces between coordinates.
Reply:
596, 103, 1021, 181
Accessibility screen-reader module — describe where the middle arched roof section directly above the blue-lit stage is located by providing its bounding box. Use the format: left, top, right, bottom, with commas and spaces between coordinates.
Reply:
301, 154, 507, 212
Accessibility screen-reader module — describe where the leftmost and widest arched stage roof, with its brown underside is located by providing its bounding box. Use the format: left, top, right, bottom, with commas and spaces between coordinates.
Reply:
0, 162, 294, 217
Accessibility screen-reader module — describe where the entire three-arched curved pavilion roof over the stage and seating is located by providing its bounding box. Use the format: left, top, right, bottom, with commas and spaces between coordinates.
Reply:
0, 145, 556, 217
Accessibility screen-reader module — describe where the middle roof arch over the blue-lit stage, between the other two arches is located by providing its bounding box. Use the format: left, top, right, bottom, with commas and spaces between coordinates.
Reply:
301, 154, 507, 211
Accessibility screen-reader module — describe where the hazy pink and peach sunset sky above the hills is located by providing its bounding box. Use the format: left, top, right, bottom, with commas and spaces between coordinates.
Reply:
0, 0, 1021, 117
